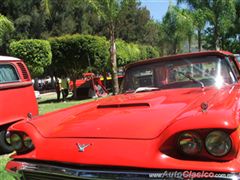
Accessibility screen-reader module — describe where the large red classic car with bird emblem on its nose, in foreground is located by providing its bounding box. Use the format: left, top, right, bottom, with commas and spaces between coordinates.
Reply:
6, 51, 240, 180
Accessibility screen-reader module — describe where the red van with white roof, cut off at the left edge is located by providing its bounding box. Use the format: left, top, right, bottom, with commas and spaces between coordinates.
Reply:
0, 56, 38, 154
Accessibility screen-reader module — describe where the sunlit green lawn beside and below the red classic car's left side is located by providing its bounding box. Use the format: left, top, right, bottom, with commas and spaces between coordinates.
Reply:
0, 93, 92, 180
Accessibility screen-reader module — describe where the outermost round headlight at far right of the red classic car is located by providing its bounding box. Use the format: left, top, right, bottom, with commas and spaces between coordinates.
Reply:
205, 131, 232, 157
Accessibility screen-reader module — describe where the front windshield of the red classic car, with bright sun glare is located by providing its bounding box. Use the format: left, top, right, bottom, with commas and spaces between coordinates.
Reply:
121, 56, 236, 93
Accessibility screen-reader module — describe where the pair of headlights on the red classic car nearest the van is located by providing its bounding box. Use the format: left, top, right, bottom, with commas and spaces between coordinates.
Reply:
10, 132, 34, 153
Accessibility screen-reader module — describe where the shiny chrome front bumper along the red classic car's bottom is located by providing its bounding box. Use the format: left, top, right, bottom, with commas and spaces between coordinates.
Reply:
6, 160, 240, 180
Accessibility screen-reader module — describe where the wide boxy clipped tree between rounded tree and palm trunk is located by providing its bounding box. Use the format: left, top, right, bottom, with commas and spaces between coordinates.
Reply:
49, 34, 109, 97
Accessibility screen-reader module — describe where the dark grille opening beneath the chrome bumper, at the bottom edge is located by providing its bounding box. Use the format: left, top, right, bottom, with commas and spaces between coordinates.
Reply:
22, 171, 85, 180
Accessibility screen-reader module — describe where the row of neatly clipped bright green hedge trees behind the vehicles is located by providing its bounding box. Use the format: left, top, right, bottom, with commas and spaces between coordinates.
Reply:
9, 34, 159, 79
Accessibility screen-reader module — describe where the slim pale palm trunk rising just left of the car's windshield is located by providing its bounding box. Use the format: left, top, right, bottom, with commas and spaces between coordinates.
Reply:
110, 26, 119, 94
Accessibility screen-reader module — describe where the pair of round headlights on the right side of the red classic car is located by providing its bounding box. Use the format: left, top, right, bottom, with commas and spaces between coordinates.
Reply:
178, 130, 232, 157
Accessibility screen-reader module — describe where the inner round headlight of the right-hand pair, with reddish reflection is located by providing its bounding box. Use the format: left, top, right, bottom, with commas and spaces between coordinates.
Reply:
178, 132, 202, 155
